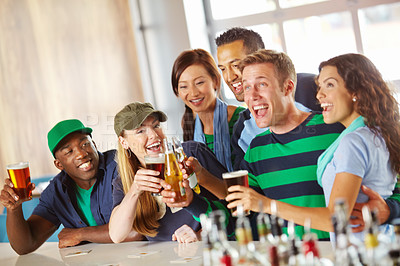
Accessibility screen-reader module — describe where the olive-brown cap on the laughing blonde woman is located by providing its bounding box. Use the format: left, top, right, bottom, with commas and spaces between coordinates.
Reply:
114, 102, 167, 136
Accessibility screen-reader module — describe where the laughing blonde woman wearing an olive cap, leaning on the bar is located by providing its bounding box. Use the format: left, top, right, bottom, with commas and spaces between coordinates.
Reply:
110, 102, 214, 243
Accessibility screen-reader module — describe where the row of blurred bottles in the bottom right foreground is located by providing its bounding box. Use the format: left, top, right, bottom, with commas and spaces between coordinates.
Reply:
200, 201, 400, 266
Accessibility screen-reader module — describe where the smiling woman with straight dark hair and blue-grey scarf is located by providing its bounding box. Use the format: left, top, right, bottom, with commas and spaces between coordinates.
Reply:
171, 49, 245, 171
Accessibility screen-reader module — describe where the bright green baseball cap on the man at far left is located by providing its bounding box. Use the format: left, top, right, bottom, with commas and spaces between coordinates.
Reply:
47, 119, 93, 156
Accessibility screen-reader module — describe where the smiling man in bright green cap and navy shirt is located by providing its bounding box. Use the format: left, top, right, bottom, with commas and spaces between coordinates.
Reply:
0, 119, 141, 254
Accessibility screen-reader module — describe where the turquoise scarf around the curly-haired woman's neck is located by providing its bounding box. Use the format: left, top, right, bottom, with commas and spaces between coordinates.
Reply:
317, 116, 365, 187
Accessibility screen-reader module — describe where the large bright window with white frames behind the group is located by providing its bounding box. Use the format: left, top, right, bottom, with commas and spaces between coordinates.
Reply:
185, 0, 400, 103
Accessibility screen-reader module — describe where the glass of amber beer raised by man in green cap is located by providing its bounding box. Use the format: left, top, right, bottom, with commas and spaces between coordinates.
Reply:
7, 162, 32, 200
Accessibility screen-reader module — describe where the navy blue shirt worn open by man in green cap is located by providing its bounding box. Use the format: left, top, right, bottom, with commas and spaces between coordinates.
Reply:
32, 150, 118, 228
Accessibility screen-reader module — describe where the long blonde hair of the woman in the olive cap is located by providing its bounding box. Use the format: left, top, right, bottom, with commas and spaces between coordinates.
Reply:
117, 139, 160, 237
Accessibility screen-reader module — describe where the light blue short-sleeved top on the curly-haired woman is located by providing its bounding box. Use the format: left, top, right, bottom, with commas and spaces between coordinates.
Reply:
321, 126, 396, 240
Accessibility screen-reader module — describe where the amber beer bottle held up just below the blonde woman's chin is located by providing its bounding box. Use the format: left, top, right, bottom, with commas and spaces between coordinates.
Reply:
163, 138, 186, 202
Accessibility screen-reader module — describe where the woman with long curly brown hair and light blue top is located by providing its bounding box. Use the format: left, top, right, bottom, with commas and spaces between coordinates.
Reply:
227, 54, 400, 238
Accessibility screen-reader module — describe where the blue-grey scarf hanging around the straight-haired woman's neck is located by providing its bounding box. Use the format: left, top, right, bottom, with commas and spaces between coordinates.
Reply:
193, 98, 233, 172
